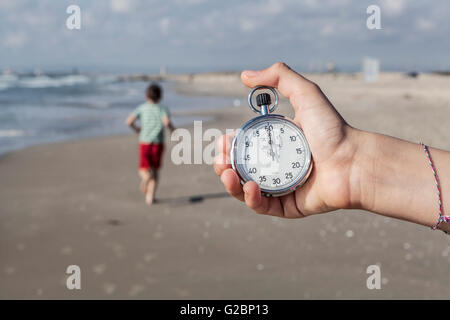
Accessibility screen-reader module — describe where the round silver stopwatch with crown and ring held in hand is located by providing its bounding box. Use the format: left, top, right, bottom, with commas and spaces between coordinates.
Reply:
230, 86, 313, 197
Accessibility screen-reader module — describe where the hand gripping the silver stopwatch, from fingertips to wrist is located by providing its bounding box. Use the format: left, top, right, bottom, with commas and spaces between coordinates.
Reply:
214, 63, 359, 218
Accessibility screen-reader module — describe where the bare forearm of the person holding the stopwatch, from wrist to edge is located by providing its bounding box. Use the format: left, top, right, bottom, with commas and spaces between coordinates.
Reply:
352, 131, 450, 231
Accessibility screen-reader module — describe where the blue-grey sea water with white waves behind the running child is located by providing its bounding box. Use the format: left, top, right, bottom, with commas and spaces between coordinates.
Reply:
0, 74, 237, 154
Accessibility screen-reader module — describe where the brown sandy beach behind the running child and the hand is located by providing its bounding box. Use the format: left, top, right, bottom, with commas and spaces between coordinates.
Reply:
0, 73, 450, 299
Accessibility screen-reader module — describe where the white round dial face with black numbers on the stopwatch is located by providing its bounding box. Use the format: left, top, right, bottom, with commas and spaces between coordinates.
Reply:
241, 121, 306, 190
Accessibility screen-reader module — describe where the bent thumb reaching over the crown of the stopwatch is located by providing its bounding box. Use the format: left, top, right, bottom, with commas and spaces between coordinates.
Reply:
241, 62, 320, 107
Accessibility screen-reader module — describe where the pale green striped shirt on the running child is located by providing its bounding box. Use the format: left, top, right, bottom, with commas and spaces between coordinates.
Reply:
134, 102, 169, 143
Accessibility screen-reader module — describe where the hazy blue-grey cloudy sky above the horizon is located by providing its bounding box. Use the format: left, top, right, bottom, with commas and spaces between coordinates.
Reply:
0, 0, 450, 72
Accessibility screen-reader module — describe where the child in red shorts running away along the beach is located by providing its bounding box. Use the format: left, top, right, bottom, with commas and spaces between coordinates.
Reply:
126, 84, 175, 205
